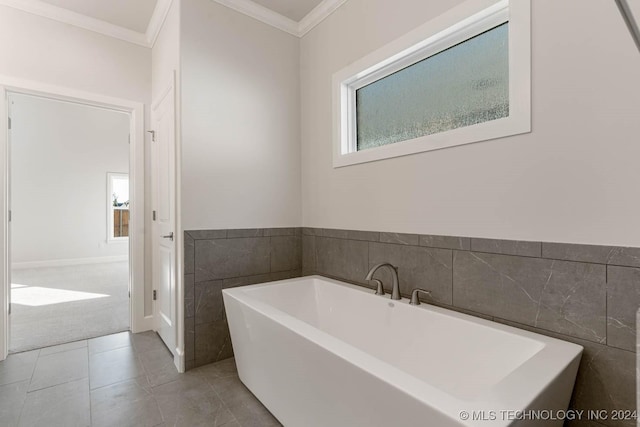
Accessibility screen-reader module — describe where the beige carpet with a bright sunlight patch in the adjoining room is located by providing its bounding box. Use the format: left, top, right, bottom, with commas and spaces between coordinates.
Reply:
9, 262, 129, 352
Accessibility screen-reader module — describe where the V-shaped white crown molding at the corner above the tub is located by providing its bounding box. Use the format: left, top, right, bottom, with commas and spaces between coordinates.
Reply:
213, 0, 348, 37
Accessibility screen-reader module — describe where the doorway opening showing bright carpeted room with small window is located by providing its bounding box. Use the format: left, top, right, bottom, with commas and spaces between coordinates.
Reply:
8, 93, 131, 352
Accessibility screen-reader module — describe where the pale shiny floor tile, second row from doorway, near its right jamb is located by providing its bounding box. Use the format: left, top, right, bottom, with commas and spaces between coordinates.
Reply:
89, 347, 144, 390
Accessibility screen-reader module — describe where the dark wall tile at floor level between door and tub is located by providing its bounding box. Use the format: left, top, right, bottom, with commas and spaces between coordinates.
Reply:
195, 319, 233, 366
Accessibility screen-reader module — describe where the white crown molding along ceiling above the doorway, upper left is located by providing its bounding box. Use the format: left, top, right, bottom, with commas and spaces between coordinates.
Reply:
0, 0, 152, 47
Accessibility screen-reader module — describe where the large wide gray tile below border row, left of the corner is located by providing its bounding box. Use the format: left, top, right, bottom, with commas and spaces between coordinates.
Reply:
195, 237, 271, 283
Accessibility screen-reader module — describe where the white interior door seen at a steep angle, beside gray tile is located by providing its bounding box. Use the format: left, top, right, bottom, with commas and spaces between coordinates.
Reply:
151, 82, 177, 356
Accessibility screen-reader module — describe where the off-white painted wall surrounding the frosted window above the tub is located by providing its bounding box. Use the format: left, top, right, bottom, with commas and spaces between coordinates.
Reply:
301, 0, 640, 246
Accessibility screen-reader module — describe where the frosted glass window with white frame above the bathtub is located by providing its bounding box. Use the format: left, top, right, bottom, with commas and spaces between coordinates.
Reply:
334, 0, 531, 167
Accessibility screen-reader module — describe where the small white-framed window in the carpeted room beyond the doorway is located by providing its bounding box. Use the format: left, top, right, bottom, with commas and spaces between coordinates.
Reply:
107, 172, 129, 241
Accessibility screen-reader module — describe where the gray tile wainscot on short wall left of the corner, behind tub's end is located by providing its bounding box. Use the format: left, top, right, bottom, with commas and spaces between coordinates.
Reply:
184, 228, 302, 369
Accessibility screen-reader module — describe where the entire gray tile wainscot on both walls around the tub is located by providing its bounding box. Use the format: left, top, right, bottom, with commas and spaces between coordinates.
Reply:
185, 228, 640, 426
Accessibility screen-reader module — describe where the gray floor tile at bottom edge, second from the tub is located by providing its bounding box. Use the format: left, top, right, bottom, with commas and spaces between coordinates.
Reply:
152, 375, 235, 427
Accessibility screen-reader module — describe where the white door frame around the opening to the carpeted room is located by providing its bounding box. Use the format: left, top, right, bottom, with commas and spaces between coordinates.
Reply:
0, 76, 153, 360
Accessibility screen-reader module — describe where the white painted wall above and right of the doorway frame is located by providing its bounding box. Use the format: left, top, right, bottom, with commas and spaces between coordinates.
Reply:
0, 6, 151, 314
